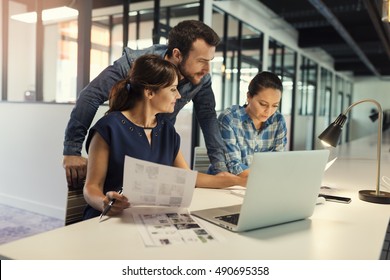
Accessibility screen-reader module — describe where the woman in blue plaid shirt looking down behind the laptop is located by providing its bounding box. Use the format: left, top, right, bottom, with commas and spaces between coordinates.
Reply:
218, 72, 287, 178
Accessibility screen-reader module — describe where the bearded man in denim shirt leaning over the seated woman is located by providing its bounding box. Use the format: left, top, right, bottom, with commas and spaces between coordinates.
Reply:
63, 20, 227, 188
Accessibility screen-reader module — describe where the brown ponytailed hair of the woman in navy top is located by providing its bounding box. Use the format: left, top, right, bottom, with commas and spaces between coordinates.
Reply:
107, 54, 179, 114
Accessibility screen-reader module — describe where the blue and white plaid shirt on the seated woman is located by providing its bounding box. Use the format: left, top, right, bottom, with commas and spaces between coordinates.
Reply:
218, 105, 287, 175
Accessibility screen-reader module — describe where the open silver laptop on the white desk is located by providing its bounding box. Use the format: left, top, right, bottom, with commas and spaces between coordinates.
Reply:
191, 150, 329, 232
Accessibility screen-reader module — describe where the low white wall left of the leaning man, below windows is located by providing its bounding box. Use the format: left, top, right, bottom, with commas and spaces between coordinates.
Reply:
0, 102, 107, 219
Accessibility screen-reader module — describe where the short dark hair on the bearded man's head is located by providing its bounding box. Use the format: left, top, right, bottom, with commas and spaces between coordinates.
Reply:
167, 20, 221, 59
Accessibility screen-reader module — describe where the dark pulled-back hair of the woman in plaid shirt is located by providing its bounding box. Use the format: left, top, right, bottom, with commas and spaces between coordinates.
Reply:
248, 71, 283, 97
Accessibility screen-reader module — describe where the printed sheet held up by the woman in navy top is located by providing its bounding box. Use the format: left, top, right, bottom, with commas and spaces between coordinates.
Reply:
123, 156, 197, 207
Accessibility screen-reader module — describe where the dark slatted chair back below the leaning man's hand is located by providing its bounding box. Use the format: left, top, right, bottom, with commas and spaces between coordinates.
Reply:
65, 186, 87, 226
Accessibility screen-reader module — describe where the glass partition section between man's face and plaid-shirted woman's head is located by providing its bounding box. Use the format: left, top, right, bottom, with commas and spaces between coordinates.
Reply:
212, 9, 263, 111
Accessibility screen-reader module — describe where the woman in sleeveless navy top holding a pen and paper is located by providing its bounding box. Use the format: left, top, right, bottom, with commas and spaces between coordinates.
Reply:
84, 55, 246, 219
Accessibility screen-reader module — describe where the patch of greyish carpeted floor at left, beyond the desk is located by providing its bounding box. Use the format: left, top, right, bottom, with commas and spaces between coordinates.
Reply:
0, 204, 64, 244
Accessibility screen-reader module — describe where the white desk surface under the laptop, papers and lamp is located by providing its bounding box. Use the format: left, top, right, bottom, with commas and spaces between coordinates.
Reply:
0, 154, 390, 260
